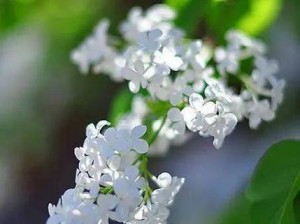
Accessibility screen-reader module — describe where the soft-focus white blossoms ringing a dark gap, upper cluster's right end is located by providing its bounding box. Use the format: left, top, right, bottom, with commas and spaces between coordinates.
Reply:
215, 31, 285, 129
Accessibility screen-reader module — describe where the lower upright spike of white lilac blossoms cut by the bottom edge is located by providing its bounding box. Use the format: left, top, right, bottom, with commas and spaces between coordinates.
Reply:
47, 121, 184, 224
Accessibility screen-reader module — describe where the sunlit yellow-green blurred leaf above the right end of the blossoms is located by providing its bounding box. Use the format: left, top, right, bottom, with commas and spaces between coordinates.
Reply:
205, 0, 282, 40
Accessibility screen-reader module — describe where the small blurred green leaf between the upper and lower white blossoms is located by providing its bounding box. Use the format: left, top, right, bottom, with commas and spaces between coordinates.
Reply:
108, 88, 133, 126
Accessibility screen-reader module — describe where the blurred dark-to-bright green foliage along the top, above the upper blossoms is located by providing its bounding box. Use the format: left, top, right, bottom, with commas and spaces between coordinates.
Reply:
165, 0, 282, 41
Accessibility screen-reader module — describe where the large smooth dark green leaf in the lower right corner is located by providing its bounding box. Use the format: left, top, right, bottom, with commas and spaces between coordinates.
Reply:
246, 140, 300, 224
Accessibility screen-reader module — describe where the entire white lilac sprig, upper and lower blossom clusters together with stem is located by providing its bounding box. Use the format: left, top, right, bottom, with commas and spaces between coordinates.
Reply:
52, 5, 285, 224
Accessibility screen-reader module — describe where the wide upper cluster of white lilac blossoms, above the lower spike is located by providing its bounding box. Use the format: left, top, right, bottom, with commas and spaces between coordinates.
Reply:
73, 5, 285, 148
